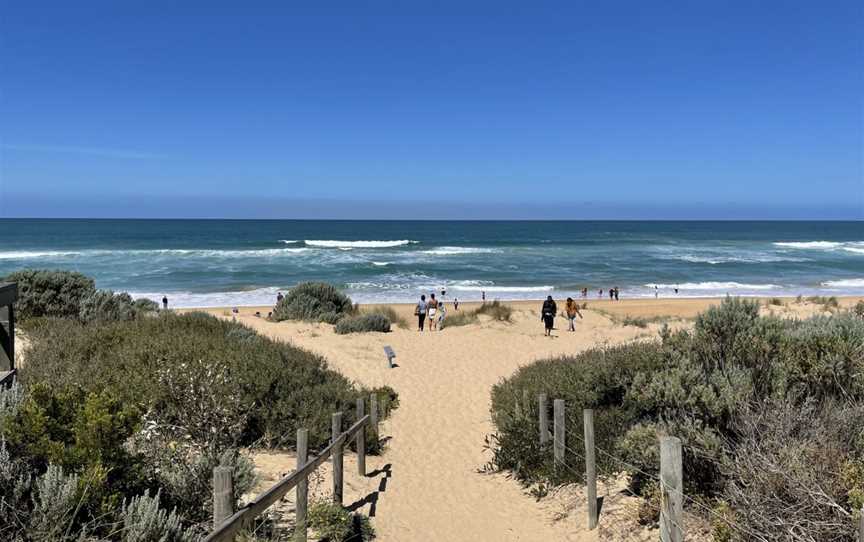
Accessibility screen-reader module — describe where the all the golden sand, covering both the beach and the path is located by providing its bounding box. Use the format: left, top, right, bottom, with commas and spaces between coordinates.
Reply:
184, 298, 859, 542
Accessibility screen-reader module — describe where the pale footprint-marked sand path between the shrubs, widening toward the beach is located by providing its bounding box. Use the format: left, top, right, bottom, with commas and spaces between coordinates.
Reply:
221, 310, 645, 542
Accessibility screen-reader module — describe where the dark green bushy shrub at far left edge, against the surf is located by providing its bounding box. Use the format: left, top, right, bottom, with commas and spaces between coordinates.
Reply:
0, 269, 96, 321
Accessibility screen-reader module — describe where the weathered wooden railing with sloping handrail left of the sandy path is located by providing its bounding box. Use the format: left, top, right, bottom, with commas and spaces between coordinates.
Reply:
204, 394, 378, 542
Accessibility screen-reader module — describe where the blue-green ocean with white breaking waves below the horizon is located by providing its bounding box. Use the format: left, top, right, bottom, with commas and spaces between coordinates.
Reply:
0, 219, 864, 307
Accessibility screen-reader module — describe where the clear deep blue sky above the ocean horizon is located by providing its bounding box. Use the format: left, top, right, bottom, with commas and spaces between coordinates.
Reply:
0, 0, 864, 219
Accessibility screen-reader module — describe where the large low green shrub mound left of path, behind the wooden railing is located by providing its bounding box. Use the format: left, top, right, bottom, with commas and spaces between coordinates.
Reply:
21, 313, 392, 447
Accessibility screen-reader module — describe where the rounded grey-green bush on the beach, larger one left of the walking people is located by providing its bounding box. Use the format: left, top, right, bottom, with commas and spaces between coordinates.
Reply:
273, 282, 355, 324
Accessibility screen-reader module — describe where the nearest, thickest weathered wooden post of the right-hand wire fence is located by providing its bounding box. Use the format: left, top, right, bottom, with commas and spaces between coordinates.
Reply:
660, 437, 684, 542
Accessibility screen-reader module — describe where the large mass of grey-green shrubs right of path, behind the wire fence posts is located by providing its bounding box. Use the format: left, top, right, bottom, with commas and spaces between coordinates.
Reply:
487, 299, 864, 540
